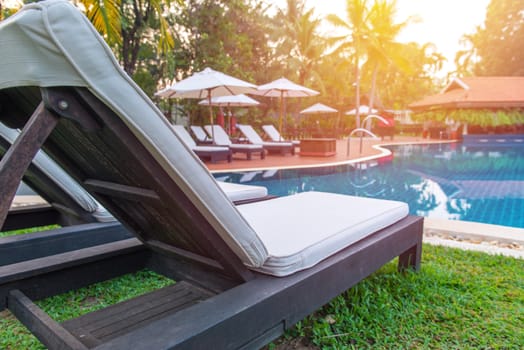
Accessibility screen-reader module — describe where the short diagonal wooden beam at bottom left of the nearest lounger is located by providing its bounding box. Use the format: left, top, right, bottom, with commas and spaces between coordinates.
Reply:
8, 290, 87, 350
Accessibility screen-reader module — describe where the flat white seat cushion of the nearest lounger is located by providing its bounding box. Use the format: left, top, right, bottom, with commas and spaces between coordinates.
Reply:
238, 192, 408, 276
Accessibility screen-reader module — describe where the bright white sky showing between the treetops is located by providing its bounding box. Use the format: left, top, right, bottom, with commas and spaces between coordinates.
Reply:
271, 0, 491, 74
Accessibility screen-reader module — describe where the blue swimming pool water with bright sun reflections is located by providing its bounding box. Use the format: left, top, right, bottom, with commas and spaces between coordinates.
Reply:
215, 143, 524, 228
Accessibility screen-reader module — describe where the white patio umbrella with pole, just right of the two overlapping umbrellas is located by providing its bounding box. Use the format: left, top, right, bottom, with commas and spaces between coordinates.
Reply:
251, 78, 319, 139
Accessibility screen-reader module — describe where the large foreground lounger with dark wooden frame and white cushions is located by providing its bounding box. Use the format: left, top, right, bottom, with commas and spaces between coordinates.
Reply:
0, 1, 422, 349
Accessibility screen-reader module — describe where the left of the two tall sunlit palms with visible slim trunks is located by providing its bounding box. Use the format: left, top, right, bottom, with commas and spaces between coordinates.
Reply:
327, 0, 370, 128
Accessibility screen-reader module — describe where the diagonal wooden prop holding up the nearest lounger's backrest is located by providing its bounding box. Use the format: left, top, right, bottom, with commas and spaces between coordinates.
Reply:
0, 103, 58, 227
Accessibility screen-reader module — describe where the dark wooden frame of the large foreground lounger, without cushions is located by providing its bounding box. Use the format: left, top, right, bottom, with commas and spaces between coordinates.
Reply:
0, 88, 422, 350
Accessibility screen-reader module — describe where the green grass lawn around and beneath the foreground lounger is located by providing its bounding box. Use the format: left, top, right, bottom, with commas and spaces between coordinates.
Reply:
0, 244, 524, 349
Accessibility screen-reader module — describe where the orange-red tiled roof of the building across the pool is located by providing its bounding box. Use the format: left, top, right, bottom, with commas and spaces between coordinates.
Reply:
409, 77, 524, 110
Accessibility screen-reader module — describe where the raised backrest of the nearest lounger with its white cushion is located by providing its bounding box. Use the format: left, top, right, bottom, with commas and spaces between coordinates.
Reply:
0, 0, 267, 266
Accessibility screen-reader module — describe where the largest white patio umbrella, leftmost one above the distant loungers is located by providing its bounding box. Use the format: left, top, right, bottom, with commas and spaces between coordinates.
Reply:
158, 68, 257, 139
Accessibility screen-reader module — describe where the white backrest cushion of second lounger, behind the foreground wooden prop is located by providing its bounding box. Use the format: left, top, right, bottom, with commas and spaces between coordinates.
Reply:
0, 123, 115, 222
